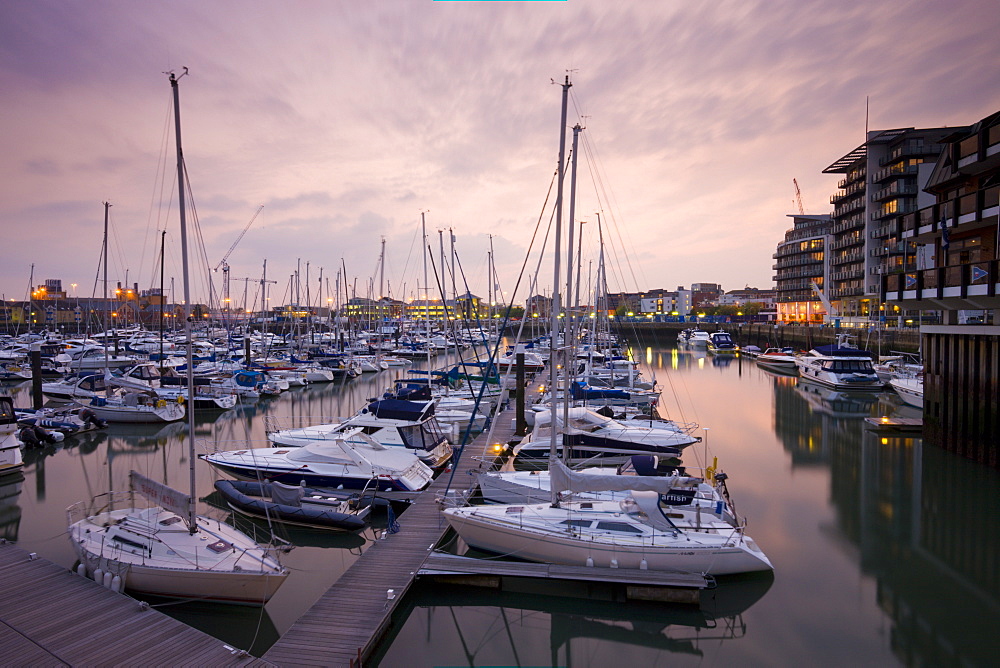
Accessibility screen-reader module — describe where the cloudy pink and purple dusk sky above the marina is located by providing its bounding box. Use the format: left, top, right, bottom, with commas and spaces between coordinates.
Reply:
0, 0, 1000, 304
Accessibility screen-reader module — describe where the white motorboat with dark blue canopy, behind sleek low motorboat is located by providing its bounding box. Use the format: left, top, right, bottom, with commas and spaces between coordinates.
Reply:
267, 399, 454, 468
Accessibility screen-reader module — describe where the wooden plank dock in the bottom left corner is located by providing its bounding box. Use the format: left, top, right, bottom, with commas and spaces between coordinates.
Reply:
0, 543, 272, 666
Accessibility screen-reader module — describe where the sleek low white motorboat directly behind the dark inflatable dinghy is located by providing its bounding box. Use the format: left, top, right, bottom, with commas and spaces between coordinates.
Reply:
200, 428, 434, 492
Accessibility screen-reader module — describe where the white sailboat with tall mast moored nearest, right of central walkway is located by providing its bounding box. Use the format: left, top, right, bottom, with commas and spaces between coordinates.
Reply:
442, 76, 773, 575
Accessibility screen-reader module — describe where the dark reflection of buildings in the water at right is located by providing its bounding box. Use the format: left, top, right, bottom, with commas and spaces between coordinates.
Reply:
774, 366, 1000, 666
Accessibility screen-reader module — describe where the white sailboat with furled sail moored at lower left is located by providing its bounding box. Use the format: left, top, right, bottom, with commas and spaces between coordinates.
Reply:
67, 69, 288, 605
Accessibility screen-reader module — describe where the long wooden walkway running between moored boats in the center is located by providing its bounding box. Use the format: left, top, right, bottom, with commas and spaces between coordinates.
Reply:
264, 400, 514, 666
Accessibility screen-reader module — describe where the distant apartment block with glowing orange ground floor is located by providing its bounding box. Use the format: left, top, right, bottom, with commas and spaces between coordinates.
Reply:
771, 214, 833, 324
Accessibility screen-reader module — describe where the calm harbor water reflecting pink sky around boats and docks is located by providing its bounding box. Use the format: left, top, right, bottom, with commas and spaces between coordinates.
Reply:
0, 346, 1000, 666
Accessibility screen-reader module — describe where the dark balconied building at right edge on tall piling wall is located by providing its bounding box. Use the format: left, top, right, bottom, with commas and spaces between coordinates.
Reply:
880, 111, 1000, 466
